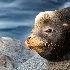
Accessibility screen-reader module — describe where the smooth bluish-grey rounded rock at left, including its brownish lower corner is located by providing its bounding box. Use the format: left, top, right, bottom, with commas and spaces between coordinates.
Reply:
0, 37, 32, 70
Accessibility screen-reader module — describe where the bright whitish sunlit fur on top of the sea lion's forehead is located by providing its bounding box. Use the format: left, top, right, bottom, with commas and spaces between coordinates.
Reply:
35, 11, 55, 23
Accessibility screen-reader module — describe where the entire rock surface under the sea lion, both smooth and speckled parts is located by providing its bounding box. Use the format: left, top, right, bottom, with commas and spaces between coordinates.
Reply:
0, 37, 70, 70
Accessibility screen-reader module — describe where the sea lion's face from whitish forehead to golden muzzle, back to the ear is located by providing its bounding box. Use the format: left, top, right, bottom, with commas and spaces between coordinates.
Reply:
25, 12, 68, 59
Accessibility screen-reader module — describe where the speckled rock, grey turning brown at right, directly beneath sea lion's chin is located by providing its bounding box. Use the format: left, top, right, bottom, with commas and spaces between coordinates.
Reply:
17, 54, 70, 70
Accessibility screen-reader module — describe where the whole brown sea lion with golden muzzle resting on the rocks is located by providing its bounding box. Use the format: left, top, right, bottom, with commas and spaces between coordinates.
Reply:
25, 7, 70, 61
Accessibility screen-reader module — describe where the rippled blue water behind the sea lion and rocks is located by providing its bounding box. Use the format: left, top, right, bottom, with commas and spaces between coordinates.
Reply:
0, 0, 70, 41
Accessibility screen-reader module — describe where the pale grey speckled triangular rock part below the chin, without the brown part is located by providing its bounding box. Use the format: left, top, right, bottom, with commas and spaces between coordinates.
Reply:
17, 53, 48, 70
